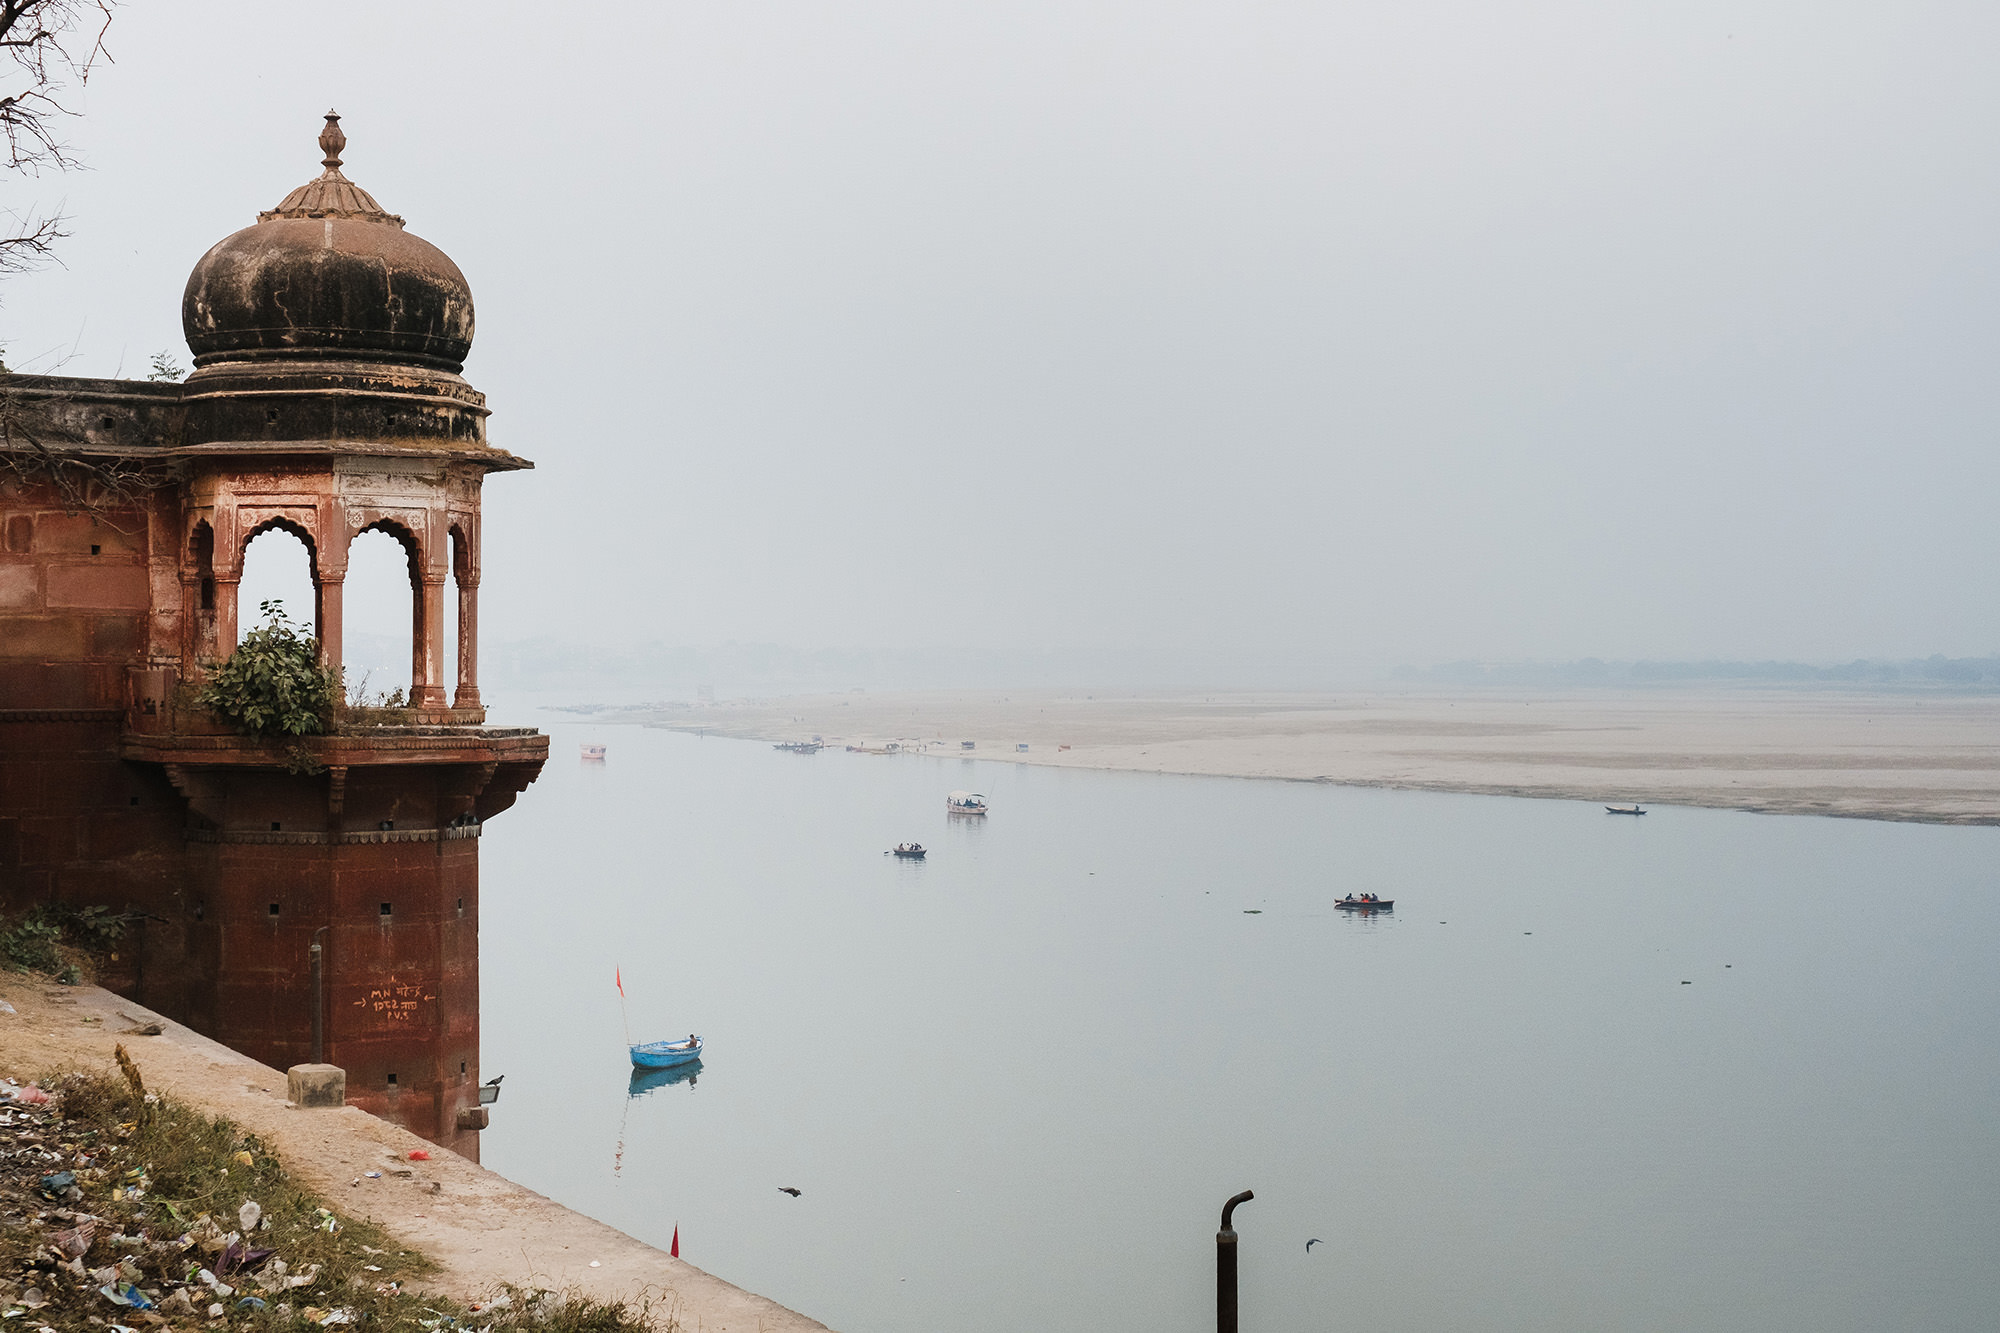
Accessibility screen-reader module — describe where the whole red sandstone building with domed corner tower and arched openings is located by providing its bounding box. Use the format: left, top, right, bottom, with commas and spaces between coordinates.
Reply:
0, 112, 548, 1157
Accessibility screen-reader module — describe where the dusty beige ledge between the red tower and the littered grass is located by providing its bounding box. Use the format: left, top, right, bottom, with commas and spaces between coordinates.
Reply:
0, 973, 826, 1333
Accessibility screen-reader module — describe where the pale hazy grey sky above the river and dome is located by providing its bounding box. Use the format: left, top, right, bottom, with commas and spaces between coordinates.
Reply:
0, 0, 2000, 675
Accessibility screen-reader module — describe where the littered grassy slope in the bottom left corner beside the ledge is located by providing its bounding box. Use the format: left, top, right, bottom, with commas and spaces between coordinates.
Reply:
0, 1047, 678, 1333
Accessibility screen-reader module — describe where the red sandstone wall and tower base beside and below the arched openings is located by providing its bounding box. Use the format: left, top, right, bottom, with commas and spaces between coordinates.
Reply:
0, 472, 540, 1159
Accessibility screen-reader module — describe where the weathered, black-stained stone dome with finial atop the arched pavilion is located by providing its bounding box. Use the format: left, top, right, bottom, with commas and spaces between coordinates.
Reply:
180, 112, 472, 374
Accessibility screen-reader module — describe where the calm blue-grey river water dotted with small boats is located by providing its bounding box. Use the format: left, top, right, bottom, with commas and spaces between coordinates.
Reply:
482, 723, 2000, 1333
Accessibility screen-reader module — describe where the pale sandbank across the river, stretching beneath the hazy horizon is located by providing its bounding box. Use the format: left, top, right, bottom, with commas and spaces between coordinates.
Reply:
624, 691, 2000, 825
